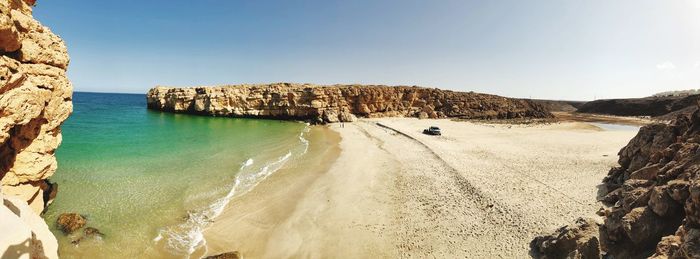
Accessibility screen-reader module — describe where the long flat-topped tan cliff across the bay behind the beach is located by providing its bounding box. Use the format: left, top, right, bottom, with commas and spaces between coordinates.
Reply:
146, 83, 552, 123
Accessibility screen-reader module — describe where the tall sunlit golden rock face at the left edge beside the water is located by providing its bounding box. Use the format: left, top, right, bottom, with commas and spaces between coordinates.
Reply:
0, 0, 72, 258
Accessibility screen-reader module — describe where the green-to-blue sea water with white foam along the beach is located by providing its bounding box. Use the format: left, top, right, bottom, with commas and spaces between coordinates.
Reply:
45, 92, 309, 258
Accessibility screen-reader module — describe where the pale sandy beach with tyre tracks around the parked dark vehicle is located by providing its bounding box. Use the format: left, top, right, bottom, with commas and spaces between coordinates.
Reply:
205, 118, 636, 258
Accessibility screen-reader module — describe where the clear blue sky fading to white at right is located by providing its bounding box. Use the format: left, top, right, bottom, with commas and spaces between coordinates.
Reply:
34, 0, 700, 100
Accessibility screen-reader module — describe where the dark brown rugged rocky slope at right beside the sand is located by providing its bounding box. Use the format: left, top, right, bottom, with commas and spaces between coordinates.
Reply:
532, 106, 700, 258
